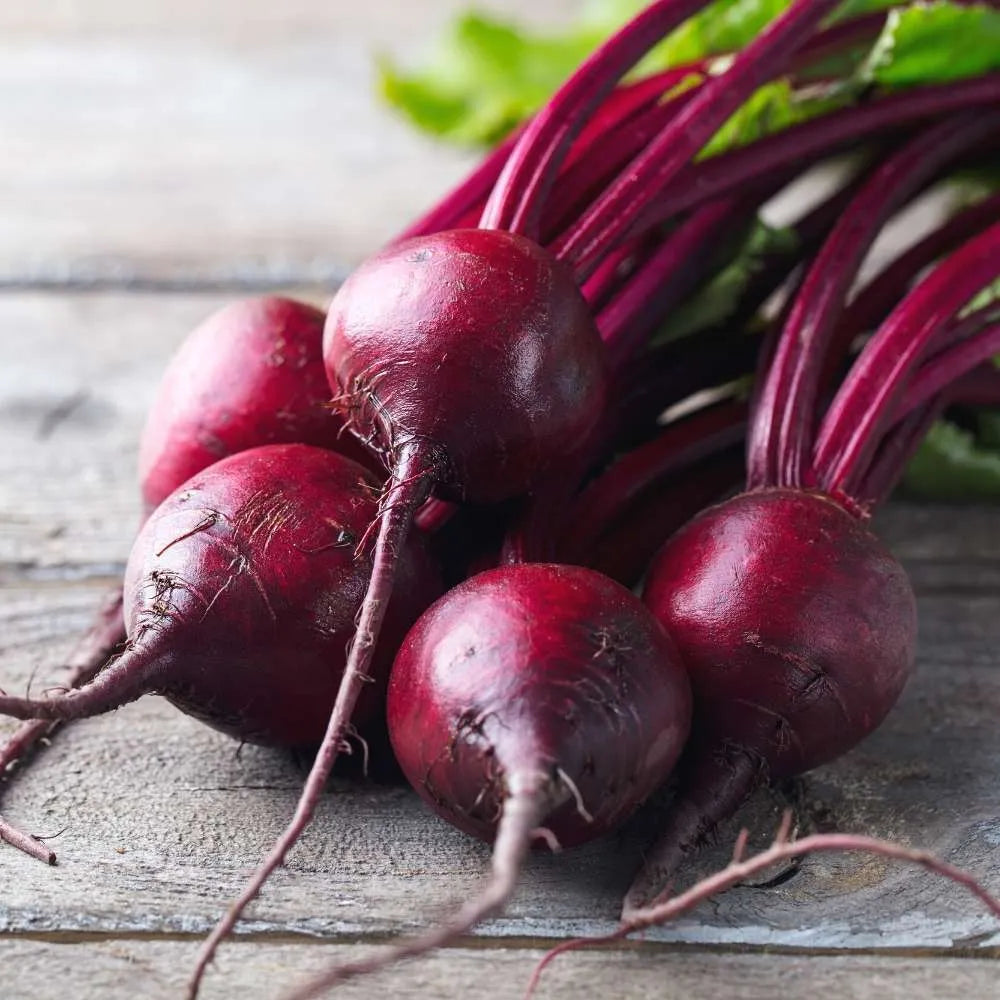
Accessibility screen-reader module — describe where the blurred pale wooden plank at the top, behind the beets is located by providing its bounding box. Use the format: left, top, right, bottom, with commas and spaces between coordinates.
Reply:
0, 0, 573, 287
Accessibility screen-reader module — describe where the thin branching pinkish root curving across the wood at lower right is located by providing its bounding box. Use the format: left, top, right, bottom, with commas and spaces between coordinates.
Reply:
524, 811, 1000, 1000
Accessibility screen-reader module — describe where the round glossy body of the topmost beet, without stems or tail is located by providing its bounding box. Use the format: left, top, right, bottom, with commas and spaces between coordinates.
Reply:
323, 229, 607, 503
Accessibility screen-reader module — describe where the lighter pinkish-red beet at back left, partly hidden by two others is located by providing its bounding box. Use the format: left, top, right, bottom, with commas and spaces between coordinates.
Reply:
139, 296, 363, 510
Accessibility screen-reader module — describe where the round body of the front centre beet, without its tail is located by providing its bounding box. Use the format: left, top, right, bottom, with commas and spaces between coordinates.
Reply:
388, 563, 691, 846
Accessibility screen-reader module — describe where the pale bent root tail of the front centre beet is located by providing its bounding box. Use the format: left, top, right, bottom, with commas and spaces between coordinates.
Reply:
284, 769, 572, 1000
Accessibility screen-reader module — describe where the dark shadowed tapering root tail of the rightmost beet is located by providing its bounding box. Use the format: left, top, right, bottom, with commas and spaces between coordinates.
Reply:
622, 746, 766, 921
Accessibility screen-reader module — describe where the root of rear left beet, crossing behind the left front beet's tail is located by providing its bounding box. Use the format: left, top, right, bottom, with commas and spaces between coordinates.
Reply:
0, 590, 125, 865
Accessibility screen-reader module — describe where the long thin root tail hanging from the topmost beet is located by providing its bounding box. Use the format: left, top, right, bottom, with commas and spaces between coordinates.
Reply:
186, 442, 438, 1000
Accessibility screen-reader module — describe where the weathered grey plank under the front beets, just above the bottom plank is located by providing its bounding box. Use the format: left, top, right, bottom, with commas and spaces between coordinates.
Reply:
0, 581, 1000, 949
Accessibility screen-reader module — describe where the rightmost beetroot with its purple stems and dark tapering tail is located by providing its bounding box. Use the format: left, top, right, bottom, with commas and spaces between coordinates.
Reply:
625, 123, 1000, 915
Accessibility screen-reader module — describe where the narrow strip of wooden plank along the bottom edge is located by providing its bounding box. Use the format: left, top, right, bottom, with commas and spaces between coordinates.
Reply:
0, 939, 997, 1000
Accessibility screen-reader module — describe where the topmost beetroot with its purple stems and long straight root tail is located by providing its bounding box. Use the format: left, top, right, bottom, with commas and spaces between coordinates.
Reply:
182, 0, 1000, 996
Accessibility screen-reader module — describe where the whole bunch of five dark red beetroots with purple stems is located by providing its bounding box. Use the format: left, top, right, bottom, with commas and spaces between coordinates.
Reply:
0, 0, 1000, 996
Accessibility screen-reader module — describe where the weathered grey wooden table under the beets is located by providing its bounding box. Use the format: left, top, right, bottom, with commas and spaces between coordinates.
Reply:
0, 0, 1000, 1000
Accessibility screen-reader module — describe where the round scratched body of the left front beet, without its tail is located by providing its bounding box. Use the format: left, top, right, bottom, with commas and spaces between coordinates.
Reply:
125, 445, 440, 747
